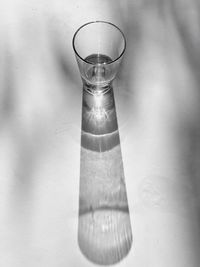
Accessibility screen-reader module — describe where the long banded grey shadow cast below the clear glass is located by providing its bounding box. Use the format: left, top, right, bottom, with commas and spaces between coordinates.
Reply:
78, 88, 132, 265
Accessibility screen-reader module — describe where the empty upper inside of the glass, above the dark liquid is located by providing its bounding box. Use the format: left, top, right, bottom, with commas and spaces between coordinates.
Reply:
73, 21, 126, 61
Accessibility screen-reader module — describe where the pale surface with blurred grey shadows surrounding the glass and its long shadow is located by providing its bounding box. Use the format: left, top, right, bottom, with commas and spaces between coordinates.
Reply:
0, 0, 200, 267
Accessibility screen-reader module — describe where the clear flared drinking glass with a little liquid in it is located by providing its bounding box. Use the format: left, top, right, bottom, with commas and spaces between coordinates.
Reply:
73, 21, 126, 94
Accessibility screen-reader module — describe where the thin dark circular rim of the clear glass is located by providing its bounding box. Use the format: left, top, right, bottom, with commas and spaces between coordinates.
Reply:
72, 20, 126, 65
